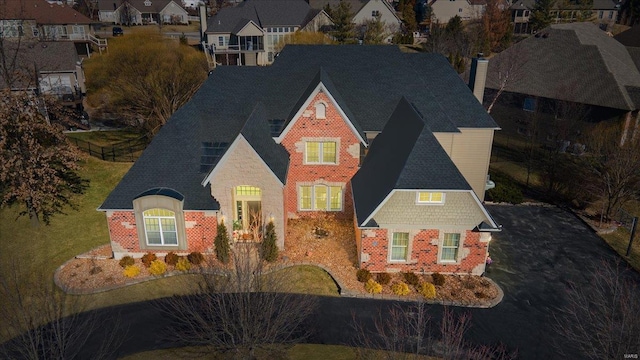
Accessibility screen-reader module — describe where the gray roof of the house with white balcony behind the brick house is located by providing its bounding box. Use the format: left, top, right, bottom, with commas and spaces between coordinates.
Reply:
206, 0, 317, 33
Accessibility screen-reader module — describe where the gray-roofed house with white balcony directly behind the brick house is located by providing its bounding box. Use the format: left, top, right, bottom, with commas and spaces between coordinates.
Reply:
201, 0, 333, 66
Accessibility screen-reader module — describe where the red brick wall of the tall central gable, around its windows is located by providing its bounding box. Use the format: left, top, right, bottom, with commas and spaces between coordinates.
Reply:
282, 92, 360, 218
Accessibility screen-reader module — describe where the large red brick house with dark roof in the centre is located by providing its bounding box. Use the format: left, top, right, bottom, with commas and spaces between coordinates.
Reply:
99, 45, 500, 275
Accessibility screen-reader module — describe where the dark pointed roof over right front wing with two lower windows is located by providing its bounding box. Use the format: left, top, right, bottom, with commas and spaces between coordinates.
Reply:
351, 97, 471, 226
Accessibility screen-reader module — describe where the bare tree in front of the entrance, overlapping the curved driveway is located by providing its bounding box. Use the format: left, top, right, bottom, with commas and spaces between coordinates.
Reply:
159, 243, 316, 359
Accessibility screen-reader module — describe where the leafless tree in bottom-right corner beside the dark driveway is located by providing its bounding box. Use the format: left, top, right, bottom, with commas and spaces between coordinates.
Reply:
554, 261, 640, 359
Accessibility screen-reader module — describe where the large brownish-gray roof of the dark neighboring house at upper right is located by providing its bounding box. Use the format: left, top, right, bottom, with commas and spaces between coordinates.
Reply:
487, 23, 640, 110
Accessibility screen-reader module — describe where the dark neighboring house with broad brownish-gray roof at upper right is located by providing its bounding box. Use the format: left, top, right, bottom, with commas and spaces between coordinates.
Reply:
485, 23, 640, 145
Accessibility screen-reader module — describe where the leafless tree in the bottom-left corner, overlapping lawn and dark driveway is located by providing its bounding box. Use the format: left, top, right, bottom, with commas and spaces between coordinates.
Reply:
0, 264, 126, 360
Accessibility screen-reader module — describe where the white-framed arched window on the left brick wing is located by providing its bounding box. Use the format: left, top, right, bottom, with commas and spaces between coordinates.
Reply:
142, 209, 178, 246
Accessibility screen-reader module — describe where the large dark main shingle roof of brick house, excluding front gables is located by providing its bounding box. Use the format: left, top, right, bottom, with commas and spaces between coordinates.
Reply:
101, 45, 497, 209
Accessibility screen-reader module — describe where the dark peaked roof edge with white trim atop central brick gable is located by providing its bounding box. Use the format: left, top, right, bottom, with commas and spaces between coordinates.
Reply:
277, 67, 367, 145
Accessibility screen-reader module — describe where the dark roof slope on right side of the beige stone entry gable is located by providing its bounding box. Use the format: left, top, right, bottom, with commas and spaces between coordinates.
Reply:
240, 102, 289, 184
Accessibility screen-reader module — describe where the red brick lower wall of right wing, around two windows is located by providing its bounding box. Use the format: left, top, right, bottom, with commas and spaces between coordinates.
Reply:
361, 229, 488, 274
